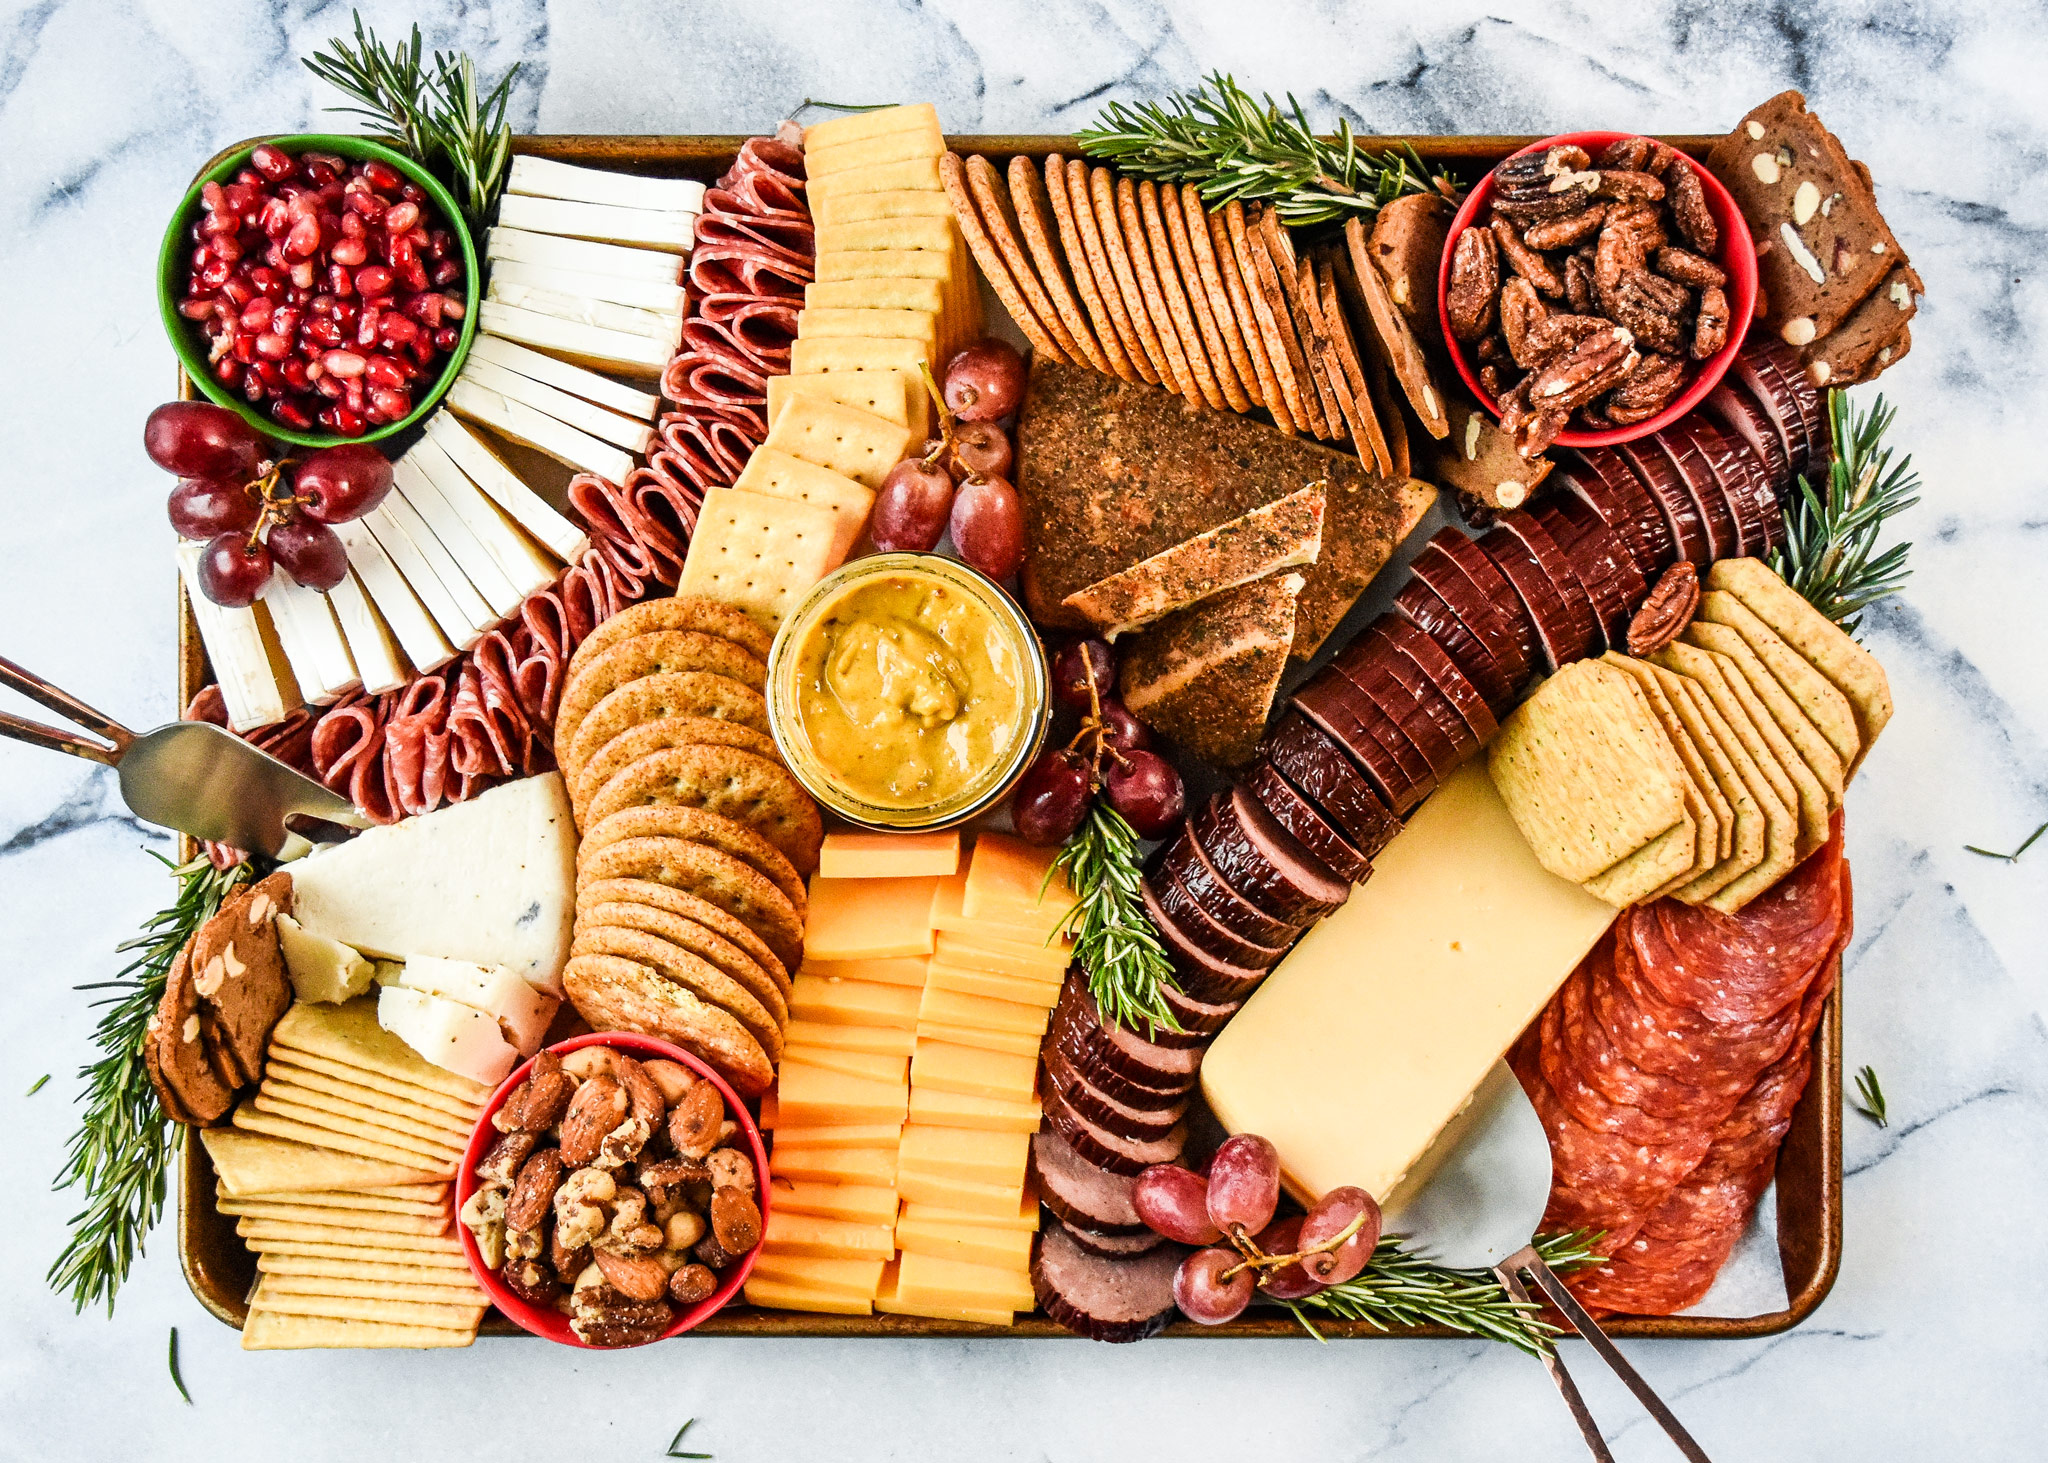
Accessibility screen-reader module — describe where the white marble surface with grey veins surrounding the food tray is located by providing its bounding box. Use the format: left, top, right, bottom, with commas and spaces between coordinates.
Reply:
0, 0, 2048, 1463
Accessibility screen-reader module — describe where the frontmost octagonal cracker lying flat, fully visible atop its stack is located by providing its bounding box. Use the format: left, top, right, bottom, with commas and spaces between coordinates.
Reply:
1487, 660, 1686, 883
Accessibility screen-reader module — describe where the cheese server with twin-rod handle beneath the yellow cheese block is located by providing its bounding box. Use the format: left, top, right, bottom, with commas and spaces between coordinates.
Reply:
1384, 1061, 1710, 1463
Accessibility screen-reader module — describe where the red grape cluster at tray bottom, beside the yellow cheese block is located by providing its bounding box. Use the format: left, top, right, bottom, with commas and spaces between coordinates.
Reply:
1130, 1133, 1380, 1326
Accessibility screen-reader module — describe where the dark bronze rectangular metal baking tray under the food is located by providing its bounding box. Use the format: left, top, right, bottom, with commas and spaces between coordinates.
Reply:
178, 135, 1841, 1340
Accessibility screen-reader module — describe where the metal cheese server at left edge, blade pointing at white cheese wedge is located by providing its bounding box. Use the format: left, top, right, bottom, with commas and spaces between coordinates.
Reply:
0, 656, 369, 859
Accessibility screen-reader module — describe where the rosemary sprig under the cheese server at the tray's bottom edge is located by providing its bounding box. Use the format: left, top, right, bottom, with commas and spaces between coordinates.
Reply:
1288, 1229, 1599, 1356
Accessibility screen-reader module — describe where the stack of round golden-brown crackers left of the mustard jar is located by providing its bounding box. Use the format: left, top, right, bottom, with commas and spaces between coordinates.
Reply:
555, 594, 823, 1096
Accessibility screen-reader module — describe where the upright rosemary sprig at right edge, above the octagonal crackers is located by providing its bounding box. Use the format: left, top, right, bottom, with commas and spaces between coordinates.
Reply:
1772, 391, 1919, 635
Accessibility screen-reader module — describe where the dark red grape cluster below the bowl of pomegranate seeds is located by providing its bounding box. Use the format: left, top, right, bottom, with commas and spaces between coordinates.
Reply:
141, 402, 391, 607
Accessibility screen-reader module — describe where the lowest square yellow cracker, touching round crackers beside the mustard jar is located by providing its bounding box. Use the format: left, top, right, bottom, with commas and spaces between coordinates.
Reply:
676, 488, 840, 625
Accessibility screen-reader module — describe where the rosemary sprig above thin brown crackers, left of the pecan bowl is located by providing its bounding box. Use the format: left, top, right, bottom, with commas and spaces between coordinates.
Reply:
1079, 72, 1452, 225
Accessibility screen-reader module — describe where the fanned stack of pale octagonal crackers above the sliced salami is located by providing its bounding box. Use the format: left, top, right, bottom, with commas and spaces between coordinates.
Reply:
1487, 559, 1890, 914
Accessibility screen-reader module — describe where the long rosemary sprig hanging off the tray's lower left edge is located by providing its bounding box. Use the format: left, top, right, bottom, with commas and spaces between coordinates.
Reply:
47, 852, 254, 1315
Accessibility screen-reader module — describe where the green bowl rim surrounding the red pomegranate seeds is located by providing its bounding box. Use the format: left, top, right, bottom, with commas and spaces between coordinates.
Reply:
156, 133, 481, 447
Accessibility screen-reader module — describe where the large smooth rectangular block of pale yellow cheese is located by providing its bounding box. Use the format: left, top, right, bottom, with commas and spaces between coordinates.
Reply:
1202, 762, 1614, 1203
